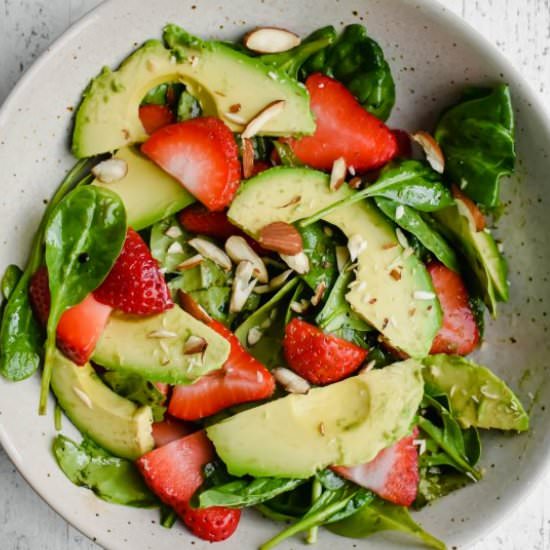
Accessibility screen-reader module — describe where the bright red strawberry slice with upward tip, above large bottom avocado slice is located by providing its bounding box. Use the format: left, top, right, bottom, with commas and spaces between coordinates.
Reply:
168, 321, 275, 420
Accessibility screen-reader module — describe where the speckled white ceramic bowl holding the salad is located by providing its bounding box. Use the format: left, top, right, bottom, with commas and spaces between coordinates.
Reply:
0, 0, 550, 550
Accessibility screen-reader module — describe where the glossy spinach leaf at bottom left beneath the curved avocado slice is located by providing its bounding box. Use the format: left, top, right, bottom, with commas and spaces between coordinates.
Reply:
53, 435, 158, 508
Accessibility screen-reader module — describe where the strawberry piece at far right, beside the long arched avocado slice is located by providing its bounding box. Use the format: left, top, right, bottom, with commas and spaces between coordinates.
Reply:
427, 262, 479, 355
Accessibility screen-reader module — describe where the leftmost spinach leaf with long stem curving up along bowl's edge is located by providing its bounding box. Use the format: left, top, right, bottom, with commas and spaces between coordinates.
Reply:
0, 159, 91, 381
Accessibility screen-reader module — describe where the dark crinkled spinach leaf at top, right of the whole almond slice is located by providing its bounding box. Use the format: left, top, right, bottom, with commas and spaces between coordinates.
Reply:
302, 24, 395, 120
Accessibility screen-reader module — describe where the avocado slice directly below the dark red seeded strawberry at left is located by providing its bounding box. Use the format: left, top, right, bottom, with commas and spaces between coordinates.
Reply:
92, 306, 230, 384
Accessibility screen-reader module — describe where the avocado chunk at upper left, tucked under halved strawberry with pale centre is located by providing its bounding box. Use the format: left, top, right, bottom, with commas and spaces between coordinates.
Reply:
92, 147, 195, 231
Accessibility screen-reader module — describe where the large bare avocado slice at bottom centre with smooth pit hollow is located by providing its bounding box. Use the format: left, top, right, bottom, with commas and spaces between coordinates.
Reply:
206, 359, 424, 479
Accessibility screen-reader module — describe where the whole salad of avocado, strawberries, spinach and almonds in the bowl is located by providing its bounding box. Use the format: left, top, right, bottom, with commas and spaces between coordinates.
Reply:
0, 24, 529, 550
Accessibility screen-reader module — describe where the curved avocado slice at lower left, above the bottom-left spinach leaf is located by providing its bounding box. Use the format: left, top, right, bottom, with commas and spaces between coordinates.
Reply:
51, 352, 154, 460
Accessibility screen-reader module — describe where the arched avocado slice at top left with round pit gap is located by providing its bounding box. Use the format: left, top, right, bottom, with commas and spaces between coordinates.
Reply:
72, 25, 315, 158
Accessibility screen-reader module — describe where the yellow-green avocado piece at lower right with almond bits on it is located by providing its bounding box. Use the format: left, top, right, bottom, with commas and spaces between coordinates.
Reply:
423, 355, 529, 432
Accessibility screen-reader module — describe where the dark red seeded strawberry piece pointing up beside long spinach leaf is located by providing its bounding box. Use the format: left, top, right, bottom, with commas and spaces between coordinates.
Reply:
94, 227, 174, 315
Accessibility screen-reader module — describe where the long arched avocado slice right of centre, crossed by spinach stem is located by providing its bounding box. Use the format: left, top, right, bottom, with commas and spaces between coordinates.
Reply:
228, 167, 441, 358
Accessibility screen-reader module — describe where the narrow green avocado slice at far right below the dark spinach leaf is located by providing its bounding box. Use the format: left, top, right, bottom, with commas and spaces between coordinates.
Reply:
432, 198, 509, 315
